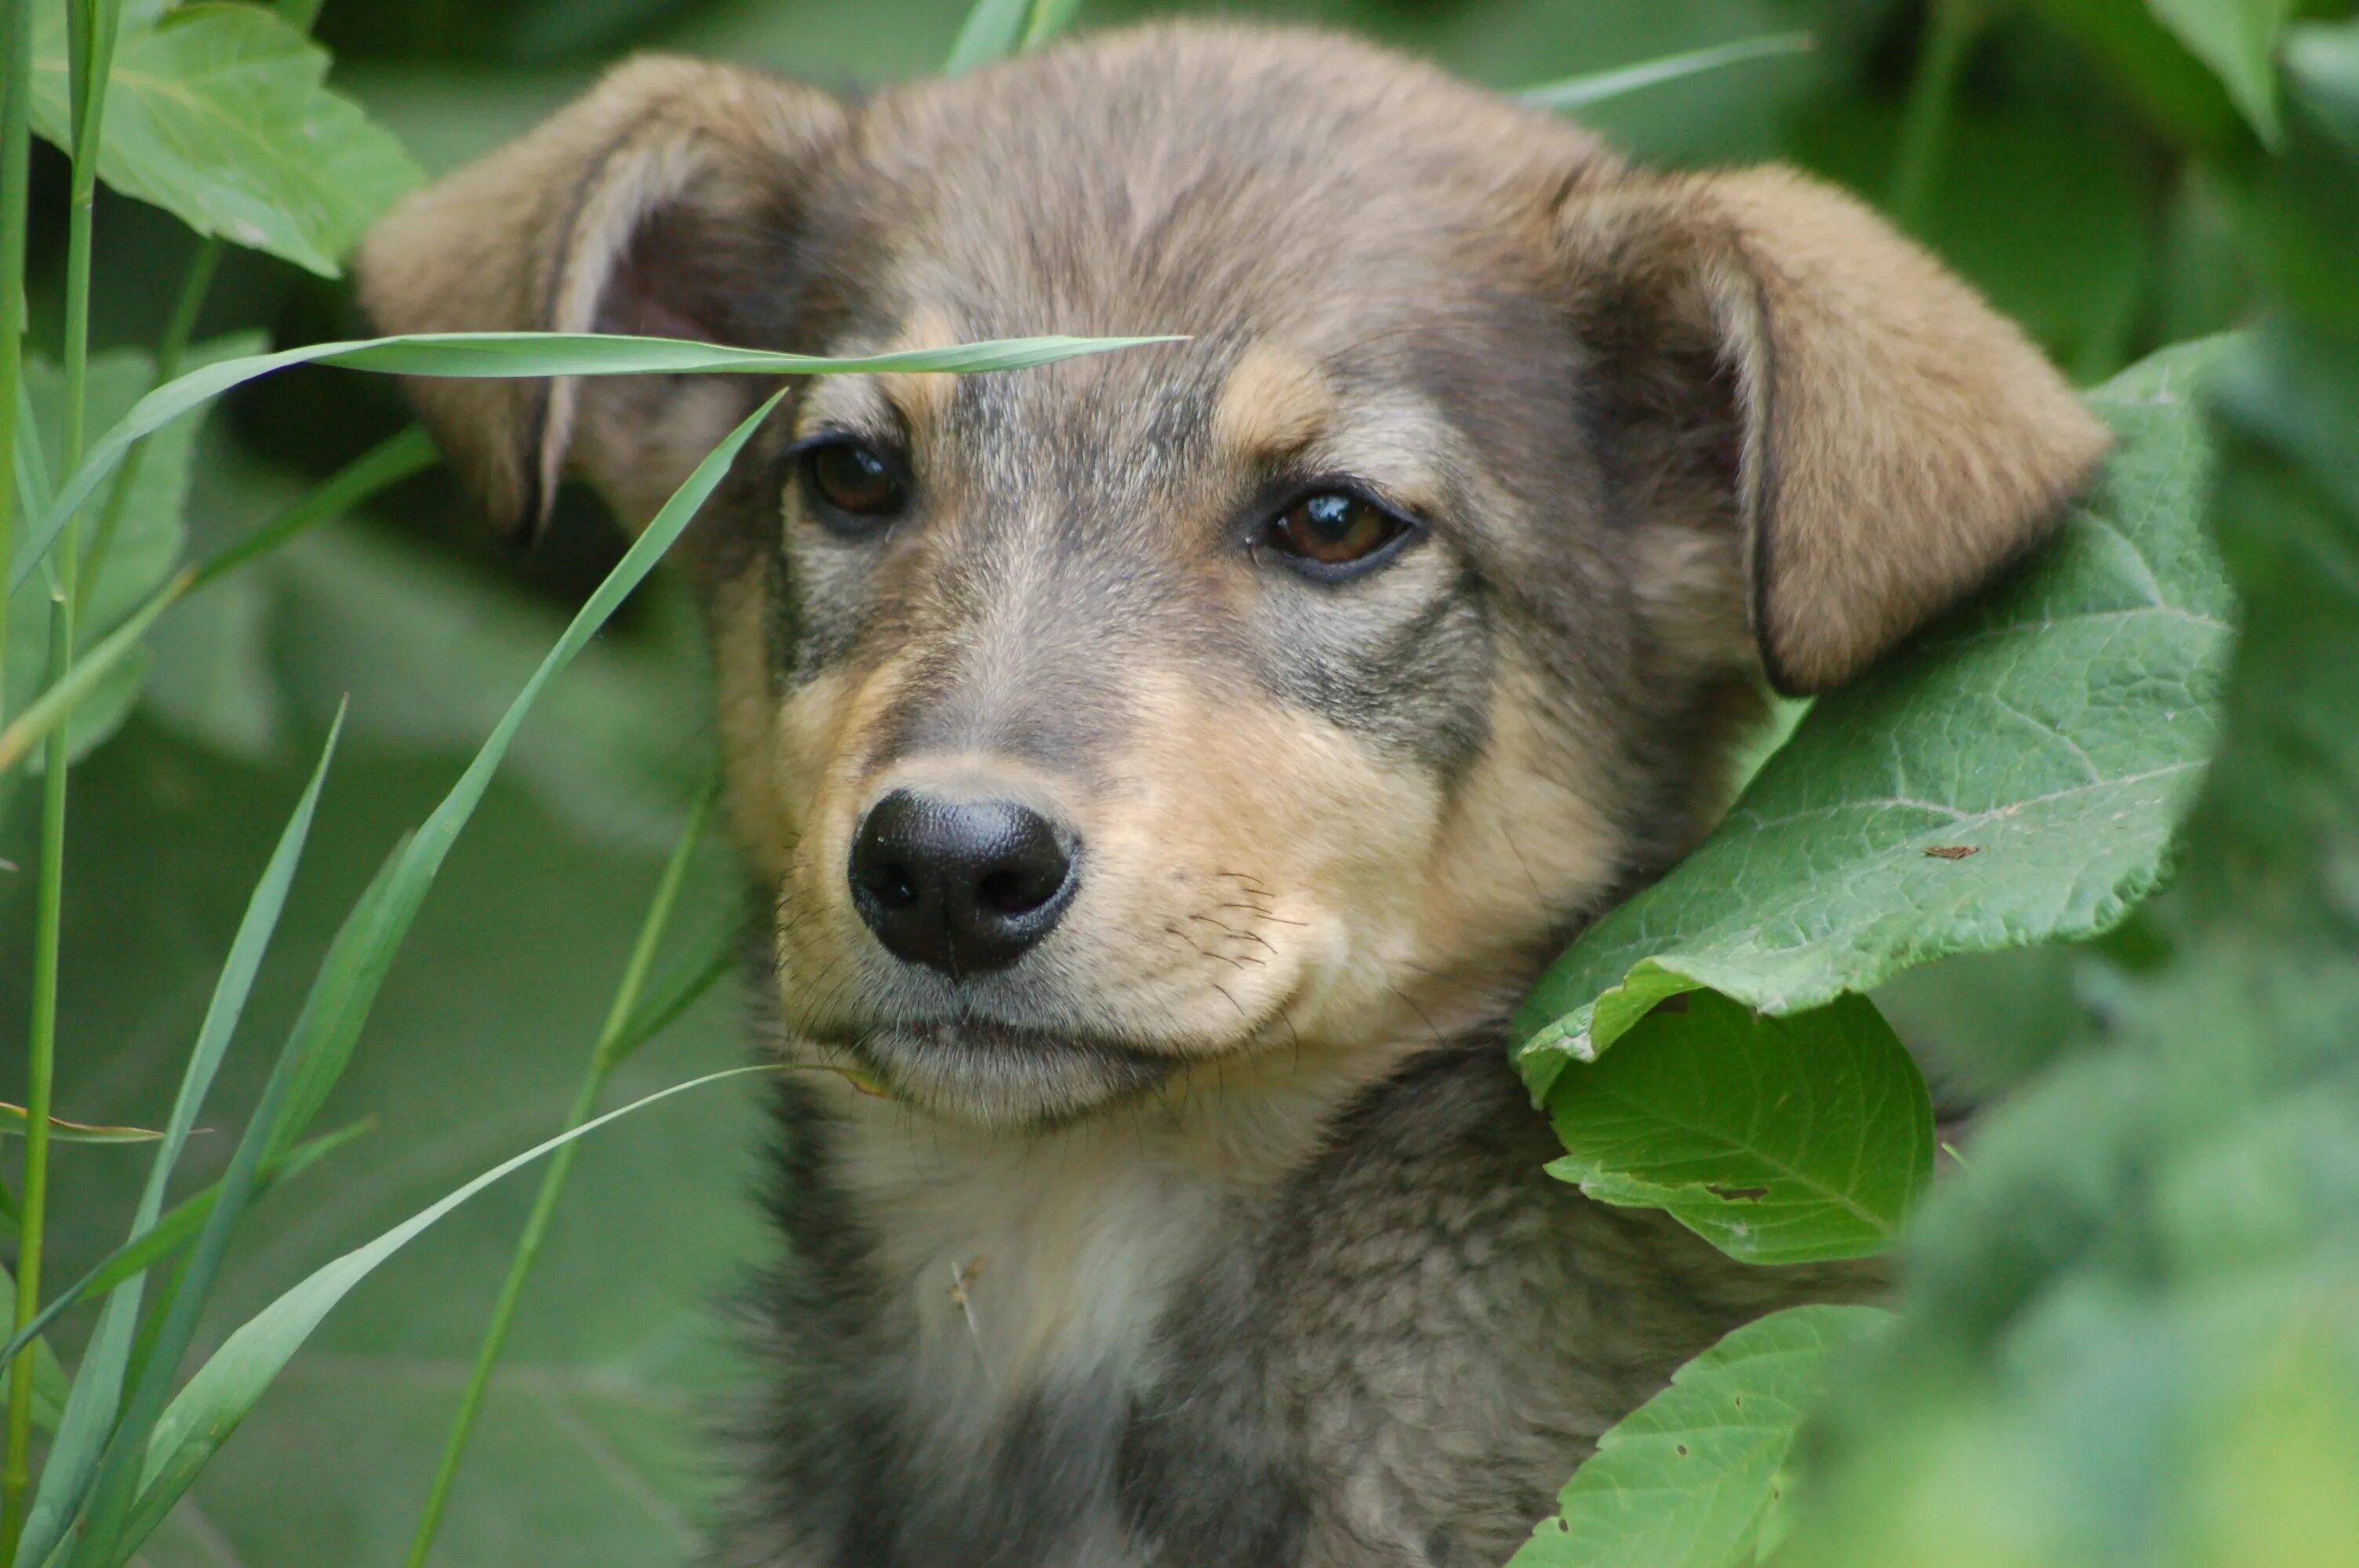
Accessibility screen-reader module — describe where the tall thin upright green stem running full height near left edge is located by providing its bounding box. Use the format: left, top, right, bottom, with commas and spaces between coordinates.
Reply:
0, 0, 120, 1561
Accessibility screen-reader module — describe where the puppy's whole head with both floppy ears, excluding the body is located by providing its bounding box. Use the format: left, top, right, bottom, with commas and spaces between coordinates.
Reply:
361, 28, 2102, 1127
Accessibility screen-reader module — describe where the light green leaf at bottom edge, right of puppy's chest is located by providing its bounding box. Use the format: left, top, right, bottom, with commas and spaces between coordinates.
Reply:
1510, 1306, 1892, 1568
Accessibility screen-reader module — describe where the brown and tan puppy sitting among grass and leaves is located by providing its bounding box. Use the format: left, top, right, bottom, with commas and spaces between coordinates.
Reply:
361, 26, 2104, 1568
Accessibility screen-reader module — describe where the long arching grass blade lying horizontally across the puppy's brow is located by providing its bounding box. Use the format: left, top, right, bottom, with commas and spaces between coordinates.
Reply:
9, 332, 1180, 592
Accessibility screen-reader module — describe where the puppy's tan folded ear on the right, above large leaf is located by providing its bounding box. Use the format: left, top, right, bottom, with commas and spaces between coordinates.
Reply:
1554, 168, 2109, 693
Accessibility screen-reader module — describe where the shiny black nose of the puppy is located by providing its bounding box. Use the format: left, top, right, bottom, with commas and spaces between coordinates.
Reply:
852, 790, 1078, 978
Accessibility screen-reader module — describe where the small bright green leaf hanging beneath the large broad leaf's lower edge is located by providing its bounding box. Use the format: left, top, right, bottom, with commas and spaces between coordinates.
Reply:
1547, 990, 1935, 1264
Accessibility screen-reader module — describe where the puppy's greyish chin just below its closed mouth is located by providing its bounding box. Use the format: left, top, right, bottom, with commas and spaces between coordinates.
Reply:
845, 1018, 1182, 1130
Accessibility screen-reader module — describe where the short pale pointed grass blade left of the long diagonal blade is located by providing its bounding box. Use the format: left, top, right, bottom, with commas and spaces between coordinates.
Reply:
9, 707, 344, 1563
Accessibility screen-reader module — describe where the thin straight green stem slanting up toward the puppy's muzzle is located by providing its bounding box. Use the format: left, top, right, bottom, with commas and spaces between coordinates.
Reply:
405, 773, 719, 1568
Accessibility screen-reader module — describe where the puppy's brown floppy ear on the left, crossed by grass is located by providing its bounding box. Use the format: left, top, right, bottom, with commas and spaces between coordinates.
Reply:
356, 56, 847, 528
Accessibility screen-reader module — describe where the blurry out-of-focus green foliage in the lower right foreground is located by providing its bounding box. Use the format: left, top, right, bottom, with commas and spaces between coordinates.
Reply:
1779, 24, 2359, 1566
